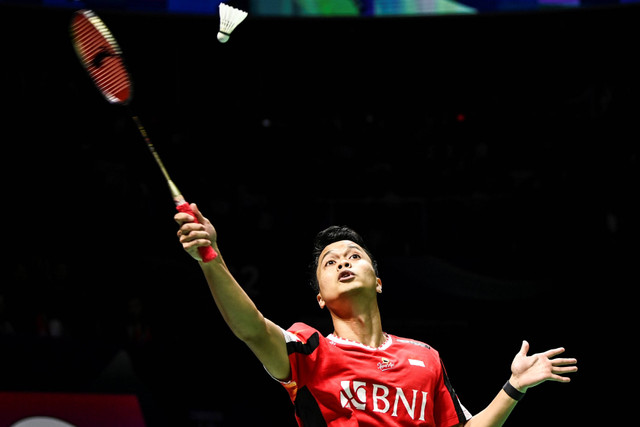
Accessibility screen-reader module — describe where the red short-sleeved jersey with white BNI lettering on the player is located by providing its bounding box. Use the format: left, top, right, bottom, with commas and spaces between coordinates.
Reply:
281, 323, 471, 427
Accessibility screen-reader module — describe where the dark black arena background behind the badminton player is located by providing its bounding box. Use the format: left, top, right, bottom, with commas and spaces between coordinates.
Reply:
0, 6, 640, 427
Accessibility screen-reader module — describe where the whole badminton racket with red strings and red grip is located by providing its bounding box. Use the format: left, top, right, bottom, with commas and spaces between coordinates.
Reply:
70, 9, 218, 262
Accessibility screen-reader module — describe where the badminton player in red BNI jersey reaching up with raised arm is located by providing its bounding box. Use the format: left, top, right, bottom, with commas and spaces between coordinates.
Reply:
175, 204, 578, 427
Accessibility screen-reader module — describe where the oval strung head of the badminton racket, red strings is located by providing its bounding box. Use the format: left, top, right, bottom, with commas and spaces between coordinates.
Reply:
69, 9, 133, 105
